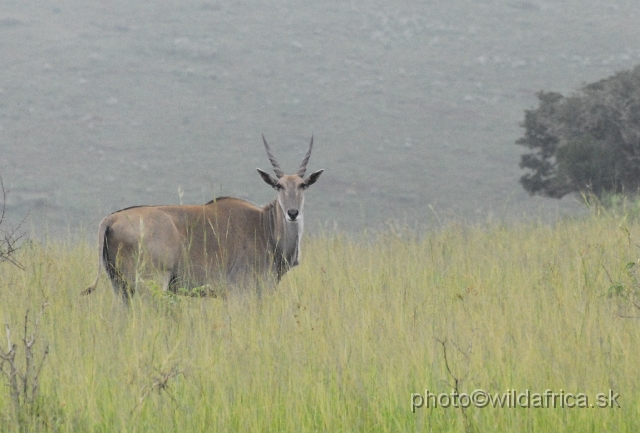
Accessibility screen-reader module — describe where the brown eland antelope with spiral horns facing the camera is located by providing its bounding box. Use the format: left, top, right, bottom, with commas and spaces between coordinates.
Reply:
83, 135, 323, 302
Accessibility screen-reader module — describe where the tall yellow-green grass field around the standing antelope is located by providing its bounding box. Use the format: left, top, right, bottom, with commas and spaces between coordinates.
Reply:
0, 208, 640, 432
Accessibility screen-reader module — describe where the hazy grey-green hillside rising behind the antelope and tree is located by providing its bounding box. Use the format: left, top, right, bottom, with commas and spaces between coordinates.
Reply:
0, 0, 640, 236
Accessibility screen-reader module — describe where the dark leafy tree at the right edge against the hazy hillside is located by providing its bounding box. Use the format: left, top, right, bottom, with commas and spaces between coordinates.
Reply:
516, 66, 640, 198
